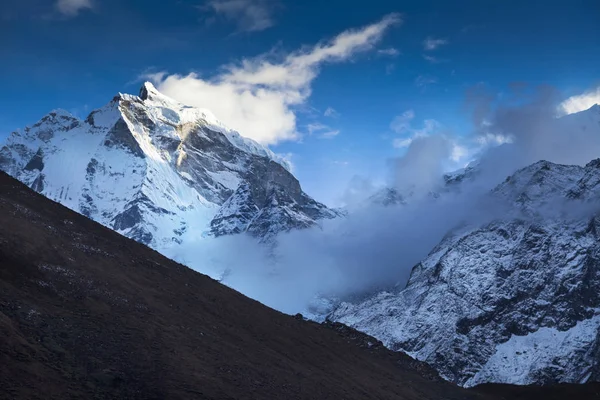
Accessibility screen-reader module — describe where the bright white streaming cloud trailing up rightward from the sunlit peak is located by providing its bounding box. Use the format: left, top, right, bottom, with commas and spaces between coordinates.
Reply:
146, 14, 401, 144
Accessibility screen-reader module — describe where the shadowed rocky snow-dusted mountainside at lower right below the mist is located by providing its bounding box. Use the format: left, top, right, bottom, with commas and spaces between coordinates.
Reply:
330, 160, 600, 386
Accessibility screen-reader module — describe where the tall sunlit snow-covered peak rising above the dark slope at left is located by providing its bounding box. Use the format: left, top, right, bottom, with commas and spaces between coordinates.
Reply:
0, 83, 337, 253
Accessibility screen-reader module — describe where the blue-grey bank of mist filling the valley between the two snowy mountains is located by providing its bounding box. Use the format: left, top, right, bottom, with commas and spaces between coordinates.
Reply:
165, 84, 600, 316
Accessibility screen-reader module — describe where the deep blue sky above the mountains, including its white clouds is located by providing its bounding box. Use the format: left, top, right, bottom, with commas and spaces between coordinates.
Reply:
0, 0, 600, 204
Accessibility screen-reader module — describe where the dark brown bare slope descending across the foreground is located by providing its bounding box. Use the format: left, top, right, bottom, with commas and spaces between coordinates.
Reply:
0, 173, 592, 400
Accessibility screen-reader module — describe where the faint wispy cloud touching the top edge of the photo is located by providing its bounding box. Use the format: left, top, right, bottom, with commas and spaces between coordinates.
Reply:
202, 0, 279, 32
